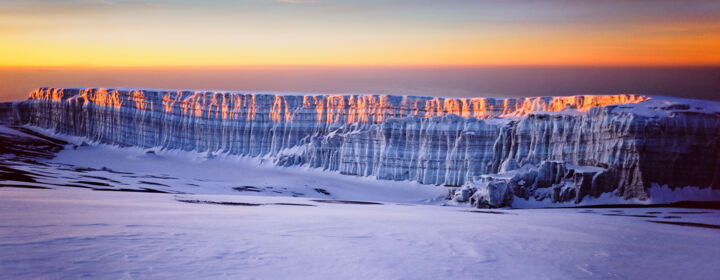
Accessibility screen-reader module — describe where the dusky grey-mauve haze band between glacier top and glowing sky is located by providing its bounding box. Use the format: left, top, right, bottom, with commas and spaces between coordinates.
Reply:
0, 66, 720, 101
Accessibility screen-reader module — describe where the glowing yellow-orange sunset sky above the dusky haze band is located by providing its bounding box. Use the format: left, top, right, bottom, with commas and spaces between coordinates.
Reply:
0, 0, 720, 67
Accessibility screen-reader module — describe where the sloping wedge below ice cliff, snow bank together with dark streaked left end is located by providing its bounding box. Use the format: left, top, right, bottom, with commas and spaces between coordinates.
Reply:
0, 125, 447, 204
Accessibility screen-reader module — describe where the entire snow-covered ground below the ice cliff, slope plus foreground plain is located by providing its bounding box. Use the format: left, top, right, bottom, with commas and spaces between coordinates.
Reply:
0, 126, 720, 279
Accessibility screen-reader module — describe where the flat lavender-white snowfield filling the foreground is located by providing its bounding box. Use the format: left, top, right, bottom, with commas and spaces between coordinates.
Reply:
0, 188, 720, 279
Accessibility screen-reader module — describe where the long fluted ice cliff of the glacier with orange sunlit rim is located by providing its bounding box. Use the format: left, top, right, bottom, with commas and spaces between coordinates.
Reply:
0, 88, 720, 207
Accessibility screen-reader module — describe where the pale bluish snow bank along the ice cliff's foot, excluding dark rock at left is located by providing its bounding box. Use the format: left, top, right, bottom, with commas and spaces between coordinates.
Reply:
46, 138, 447, 203
